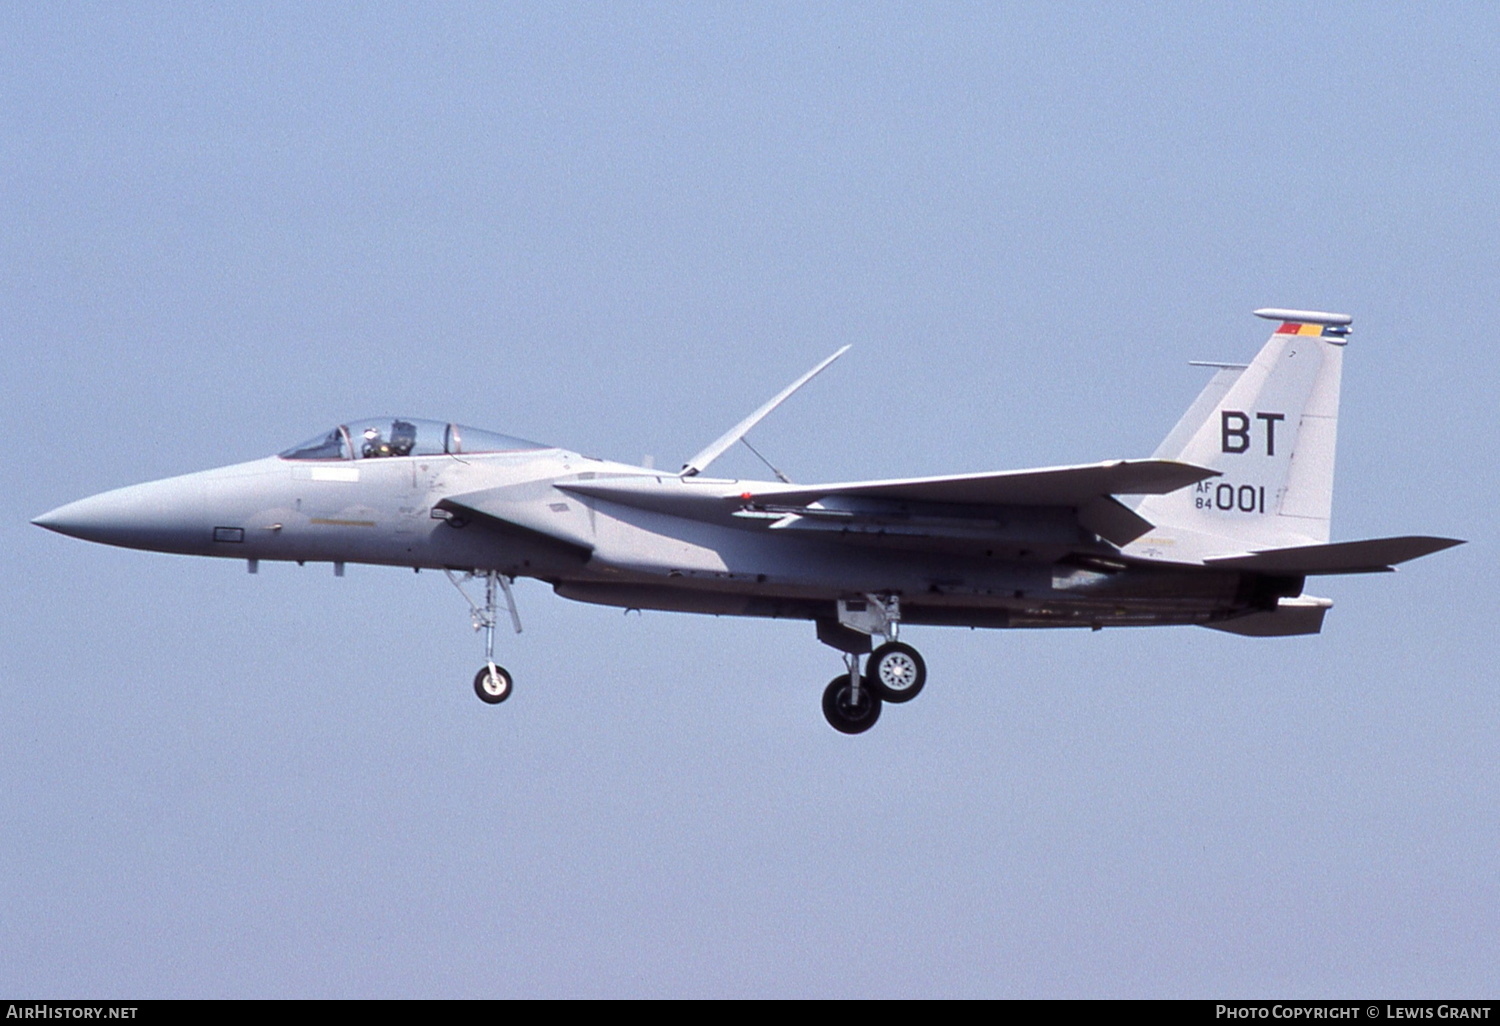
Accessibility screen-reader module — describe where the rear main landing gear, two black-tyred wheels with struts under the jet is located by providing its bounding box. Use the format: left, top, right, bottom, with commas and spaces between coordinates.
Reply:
818, 596, 927, 734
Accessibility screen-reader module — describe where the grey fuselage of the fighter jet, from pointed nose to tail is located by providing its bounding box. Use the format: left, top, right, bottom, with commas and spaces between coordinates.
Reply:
29, 449, 1278, 627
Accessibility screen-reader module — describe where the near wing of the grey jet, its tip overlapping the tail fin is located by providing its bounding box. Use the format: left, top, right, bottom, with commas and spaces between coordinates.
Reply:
753, 459, 1218, 506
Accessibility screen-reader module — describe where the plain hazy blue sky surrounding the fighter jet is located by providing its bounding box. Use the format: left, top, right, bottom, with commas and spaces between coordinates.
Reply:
0, 3, 1500, 998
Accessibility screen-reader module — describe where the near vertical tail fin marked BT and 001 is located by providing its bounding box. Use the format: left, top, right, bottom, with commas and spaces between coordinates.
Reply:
1136, 309, 1352, 555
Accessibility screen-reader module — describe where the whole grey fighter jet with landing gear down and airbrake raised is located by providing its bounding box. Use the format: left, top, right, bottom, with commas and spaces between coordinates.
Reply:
33, 309, 1460, 734
